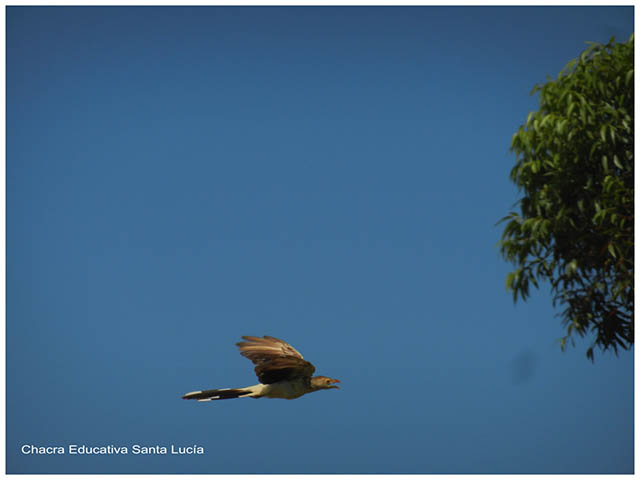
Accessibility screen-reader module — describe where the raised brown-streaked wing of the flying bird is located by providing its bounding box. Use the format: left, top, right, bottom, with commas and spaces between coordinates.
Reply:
237, 335, 316, 384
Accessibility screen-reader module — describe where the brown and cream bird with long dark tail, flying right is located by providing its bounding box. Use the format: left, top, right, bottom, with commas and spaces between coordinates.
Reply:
182, 335, 340, 402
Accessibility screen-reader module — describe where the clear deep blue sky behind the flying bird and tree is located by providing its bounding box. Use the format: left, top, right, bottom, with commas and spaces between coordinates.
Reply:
6, 7, 633, 473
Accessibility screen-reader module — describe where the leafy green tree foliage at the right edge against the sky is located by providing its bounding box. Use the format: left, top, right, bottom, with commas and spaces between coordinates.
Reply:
499, 35, 634, 361
